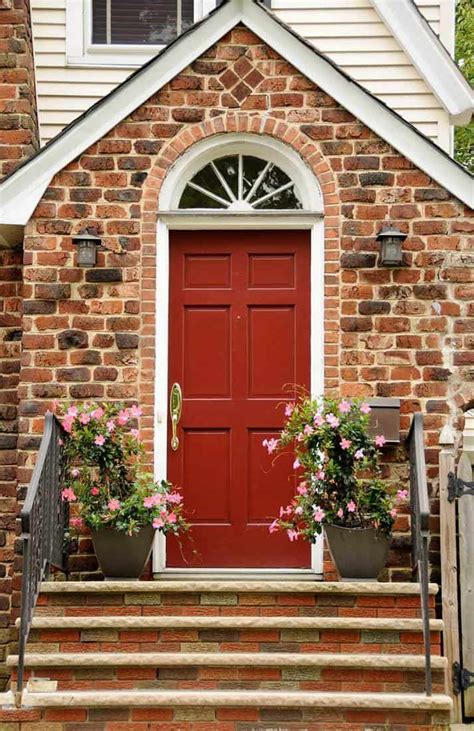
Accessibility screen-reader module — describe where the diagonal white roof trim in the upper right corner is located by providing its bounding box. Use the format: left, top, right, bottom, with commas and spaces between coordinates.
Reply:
370, 0, 474, 125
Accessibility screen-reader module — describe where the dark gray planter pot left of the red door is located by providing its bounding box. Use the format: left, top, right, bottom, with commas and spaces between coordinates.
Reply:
91, 525, 155, 579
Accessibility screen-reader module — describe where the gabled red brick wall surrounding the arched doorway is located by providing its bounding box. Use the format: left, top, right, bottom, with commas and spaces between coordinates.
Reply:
15, 28, 474, 578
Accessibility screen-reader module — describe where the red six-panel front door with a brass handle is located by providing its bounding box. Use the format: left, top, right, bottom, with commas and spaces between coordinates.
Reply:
167, 231, 310, 568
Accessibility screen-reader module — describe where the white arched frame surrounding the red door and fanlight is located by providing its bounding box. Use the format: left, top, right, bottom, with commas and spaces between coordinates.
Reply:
153, 132, 325, 579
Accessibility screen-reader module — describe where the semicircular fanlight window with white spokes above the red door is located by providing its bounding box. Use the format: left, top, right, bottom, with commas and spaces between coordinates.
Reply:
179, 154, 303, 212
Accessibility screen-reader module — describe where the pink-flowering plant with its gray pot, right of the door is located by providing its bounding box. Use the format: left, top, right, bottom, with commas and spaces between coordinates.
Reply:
263, 395, 408, 580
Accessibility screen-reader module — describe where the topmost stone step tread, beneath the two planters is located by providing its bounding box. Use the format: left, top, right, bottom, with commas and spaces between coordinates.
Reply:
41, 580, 438, 596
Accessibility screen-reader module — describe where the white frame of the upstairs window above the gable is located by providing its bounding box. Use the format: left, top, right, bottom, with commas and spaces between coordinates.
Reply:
66, 0, 210, 68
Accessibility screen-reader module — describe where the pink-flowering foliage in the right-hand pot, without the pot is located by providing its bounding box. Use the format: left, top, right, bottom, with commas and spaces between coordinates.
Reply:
264, 396, 407, 541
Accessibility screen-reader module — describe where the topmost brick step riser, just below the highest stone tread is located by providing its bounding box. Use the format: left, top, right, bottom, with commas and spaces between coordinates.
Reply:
36, 592, 434, 619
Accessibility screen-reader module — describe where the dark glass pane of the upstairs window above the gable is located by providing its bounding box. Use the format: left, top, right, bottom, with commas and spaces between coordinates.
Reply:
92, 0, 193, 45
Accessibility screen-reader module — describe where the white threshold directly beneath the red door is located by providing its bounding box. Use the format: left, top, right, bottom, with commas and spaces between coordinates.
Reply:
153, 568, 323, 581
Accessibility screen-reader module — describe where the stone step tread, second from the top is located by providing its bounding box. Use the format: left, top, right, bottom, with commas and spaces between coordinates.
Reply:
21, 614, 443, 632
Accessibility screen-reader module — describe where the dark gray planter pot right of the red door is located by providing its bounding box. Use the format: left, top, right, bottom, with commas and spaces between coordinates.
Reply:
324, 525, 392, 581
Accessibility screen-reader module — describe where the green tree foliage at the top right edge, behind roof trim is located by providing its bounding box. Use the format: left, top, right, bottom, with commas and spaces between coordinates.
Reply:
454, 0, 474, 173
